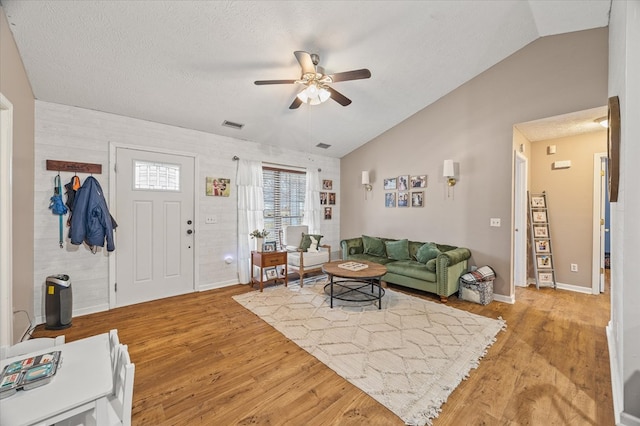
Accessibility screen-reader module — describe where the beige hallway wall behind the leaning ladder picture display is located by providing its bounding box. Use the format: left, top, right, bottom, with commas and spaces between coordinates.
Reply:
530, 129, 607, 292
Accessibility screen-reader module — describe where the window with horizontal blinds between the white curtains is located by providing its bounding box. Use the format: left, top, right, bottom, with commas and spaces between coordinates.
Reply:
262, 167, 307, 244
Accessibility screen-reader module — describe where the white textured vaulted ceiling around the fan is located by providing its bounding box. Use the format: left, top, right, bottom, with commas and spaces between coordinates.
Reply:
2, 0, 610, 158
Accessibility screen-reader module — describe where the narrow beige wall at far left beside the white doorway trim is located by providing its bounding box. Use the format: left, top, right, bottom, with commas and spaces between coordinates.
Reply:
0, 6, 34, 342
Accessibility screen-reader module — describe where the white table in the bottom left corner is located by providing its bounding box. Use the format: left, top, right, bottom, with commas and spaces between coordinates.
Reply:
0, 333, 113, 426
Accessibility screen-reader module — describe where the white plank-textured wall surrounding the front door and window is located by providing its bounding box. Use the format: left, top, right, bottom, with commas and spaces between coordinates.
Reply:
31, 101, 341, 322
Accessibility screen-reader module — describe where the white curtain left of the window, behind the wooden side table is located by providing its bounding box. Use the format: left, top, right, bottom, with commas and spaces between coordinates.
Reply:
236, 160, 264, 284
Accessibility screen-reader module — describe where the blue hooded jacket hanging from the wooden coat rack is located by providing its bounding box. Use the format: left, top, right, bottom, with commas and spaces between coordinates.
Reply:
69, 176, 117, 251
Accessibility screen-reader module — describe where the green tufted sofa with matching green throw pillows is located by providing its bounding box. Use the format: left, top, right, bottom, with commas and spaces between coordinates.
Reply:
340, 235, 471, 303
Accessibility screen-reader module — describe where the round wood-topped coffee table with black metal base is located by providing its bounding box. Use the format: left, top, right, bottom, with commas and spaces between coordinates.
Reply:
322, 260, 387, 309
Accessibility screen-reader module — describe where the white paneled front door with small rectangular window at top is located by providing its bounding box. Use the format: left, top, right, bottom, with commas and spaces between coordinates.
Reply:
115, 148, 194, 306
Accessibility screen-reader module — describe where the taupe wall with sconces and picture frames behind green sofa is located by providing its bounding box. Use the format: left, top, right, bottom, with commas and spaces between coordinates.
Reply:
340, 28, 608, 296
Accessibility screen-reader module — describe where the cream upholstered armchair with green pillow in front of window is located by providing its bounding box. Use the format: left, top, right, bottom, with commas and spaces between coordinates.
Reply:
279, 225, 331, 287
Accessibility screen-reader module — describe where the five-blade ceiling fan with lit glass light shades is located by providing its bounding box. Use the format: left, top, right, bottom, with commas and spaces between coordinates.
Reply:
255, 50, 371, 109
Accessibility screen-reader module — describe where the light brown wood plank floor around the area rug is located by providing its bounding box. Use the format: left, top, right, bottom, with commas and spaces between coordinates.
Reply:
34, 274, 614, 426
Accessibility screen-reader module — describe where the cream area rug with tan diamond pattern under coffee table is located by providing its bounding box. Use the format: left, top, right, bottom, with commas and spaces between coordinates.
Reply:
233, 278, 506, 425
